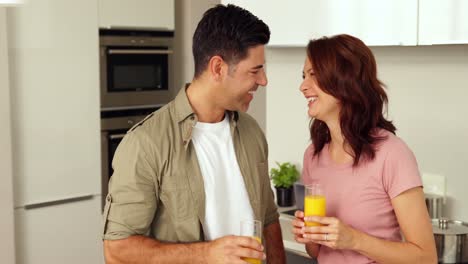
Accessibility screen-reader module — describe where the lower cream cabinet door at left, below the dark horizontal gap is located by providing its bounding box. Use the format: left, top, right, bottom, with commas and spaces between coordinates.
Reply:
15, 196, 104, 264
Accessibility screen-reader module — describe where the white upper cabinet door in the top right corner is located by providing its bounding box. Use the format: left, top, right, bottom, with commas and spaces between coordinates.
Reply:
418, 0, 468, 45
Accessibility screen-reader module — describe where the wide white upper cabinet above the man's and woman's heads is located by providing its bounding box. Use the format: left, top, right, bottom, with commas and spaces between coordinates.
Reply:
222, 0, 418, 46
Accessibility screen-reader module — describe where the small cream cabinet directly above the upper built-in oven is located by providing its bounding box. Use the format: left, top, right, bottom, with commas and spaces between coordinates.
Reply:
98, 0, 174, 30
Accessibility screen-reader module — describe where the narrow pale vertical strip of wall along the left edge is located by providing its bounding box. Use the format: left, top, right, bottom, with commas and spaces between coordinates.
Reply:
0, 7, 15, 264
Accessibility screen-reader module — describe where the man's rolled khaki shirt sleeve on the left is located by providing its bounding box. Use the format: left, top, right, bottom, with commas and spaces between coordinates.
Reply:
103, 132, 157, 240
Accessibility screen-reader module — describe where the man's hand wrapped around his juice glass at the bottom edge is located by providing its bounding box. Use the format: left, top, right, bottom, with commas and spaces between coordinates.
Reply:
206, 236, 266, 264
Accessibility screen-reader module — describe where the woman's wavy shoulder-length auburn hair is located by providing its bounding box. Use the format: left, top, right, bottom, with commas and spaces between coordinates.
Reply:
307, 34, 396, 166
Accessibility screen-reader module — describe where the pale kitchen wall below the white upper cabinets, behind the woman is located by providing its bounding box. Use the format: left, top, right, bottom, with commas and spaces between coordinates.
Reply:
266, 45, 468, 221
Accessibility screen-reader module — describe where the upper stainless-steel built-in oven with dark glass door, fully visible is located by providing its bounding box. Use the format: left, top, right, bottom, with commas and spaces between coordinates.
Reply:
99, 29, 176, 110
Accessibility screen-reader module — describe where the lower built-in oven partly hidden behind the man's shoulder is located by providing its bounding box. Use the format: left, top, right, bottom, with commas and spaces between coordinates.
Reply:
101, 107, 158, 208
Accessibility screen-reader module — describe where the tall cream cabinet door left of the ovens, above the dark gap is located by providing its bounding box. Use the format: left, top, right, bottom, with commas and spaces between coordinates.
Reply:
7, 0, 101, 208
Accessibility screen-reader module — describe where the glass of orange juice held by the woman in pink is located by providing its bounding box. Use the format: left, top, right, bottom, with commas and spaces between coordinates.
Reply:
304, 183, 327, 226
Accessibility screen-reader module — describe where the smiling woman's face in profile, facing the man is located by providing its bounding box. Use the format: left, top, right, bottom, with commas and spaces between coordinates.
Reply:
300, 57, 341, 123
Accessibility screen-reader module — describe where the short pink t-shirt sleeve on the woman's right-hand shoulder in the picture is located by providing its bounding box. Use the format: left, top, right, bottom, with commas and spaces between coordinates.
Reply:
383, 138, 422, 199
